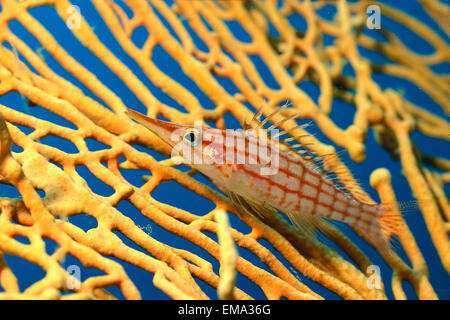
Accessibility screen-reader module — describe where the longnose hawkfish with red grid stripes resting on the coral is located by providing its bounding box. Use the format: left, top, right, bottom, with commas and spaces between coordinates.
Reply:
127, 105, 399, 252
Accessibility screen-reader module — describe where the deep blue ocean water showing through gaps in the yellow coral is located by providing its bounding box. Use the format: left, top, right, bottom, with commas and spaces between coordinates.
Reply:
0, 0, 450, 299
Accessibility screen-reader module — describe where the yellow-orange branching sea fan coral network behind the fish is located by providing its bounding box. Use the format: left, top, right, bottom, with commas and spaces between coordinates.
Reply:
0, 0, 450, 299
